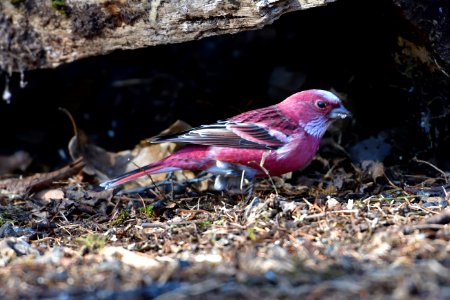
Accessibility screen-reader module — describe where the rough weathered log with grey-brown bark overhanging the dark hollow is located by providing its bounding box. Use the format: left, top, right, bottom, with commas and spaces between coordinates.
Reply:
0, 0, 335, 72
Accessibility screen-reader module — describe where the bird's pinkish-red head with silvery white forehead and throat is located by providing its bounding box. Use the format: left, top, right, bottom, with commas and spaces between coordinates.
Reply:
278, 90, 351, 138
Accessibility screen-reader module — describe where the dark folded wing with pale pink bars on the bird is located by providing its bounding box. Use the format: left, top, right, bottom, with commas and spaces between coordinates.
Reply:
150, 120, 287, 149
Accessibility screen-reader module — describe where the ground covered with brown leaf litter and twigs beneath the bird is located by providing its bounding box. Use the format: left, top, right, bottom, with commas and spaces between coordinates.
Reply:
0, 116, 450, 299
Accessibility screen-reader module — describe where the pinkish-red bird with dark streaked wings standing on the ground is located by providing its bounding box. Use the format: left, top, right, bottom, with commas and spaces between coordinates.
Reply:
100, 89, 351, 189
